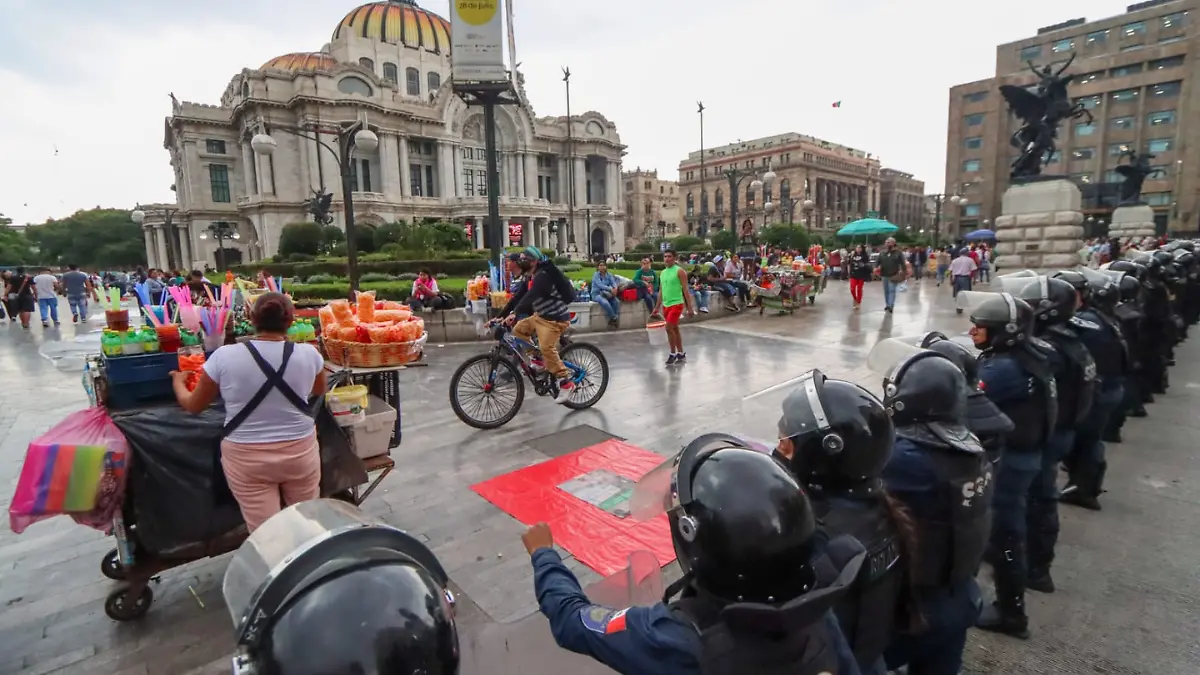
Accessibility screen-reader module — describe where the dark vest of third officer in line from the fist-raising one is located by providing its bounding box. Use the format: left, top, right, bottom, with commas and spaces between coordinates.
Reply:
911, 444, 993, 589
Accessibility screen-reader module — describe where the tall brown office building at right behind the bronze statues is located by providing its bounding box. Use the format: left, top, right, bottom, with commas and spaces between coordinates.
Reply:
946, 0, 1200, 234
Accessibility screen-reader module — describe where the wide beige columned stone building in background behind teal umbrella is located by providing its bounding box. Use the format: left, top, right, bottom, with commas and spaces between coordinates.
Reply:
679, 133, 880, 235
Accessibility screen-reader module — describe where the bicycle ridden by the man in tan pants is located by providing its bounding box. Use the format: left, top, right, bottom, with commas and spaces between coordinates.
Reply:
450, 322, 608, 429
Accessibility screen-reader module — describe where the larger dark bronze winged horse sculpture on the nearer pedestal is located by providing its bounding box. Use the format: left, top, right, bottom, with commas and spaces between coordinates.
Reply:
1000, 54, 1094, 183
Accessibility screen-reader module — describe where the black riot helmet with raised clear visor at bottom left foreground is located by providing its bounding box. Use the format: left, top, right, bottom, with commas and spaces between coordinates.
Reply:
222, 500, 460, 675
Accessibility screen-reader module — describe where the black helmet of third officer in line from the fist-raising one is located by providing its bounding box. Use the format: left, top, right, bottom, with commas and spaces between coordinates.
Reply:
883, 350, 971, 426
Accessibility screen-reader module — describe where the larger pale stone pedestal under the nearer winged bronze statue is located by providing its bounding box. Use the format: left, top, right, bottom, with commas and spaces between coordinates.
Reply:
995, 179, 1084, 274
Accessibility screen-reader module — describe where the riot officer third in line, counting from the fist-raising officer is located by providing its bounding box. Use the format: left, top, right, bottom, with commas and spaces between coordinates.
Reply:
883, 350, 992, 675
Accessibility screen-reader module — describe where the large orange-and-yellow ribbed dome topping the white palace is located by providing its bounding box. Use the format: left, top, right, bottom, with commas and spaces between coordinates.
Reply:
334, 0, 450, 54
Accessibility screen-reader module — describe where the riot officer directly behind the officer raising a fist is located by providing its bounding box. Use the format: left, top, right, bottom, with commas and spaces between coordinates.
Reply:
775, 370, 913, 675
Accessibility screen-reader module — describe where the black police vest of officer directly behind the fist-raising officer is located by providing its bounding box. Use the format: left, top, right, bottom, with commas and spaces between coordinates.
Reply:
812, 494, 905, 669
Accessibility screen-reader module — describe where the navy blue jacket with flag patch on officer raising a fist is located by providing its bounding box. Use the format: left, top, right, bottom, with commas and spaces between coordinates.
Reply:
532, 549, 860, 675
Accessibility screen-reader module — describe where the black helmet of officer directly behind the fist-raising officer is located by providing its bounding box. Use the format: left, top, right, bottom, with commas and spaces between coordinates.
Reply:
779, 370, 895, 494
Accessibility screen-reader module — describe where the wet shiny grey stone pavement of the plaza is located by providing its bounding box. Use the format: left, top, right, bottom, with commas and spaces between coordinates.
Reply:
0, 281, 1200, 675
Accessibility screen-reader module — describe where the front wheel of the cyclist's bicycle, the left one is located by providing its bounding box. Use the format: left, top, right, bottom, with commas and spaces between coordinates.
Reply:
450, 354, 524, 429
